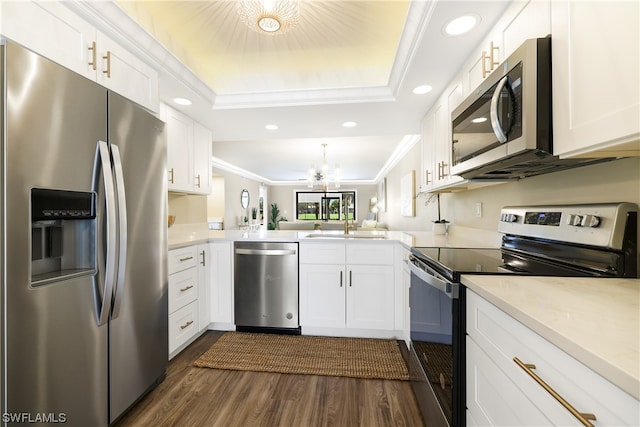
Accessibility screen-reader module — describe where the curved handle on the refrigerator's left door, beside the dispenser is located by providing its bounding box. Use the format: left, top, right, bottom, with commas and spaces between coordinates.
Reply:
93, 141, 117, 326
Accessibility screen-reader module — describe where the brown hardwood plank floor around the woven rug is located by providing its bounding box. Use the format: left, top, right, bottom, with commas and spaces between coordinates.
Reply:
116, 331, 424, 427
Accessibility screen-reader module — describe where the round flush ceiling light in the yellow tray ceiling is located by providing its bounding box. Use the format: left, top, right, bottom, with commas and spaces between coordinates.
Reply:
238, 0, 300, 35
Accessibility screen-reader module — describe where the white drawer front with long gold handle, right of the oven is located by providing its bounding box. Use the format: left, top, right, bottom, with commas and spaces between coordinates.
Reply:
467, 291, 640, 425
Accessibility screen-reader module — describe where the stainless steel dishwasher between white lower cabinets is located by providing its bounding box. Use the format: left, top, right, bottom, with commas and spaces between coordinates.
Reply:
234, 242, 300, 334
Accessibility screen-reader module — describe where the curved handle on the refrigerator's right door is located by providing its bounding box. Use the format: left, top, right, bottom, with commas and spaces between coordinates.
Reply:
111, 144, 127, 319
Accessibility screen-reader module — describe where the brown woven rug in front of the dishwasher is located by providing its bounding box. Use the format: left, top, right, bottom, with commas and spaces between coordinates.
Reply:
195, 332, 409, 380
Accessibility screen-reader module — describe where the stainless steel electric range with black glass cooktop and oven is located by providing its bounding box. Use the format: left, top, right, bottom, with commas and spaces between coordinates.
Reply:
408, 203, 640, 425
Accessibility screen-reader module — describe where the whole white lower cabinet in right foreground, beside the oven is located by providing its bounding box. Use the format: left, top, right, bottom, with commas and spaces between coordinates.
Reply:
466, 290, 640, 426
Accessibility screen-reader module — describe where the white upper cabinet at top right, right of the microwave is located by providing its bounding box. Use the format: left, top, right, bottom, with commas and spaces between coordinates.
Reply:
551, 1, 640, 157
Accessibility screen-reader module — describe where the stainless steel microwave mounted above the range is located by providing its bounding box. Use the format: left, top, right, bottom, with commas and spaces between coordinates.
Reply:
451, 37, 556, 180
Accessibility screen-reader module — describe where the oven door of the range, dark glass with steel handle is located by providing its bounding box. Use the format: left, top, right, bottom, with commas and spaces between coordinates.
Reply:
409, 257, 465, 426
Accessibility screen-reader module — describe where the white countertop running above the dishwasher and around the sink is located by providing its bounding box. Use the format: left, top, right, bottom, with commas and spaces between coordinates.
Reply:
169, 223, 501, 249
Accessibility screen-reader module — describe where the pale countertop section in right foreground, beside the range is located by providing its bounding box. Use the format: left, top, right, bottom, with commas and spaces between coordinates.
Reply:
462, 275, 640, 399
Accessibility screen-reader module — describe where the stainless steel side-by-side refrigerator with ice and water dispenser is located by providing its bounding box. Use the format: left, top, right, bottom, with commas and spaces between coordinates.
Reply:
0, 40, 168, 426
